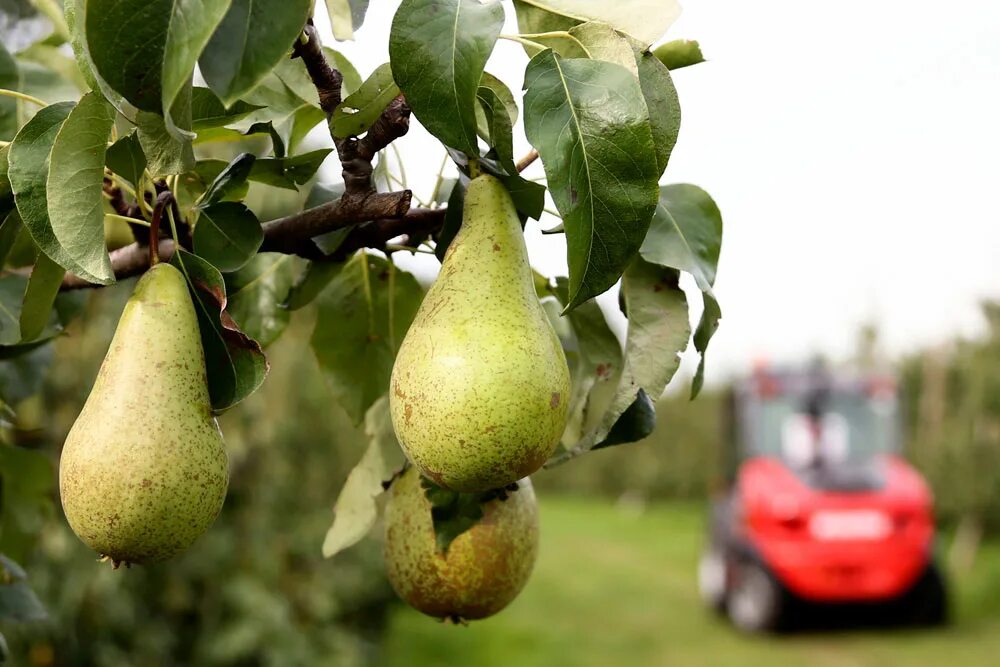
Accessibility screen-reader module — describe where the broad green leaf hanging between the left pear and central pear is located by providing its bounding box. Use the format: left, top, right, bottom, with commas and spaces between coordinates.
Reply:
310, 253, 423, 424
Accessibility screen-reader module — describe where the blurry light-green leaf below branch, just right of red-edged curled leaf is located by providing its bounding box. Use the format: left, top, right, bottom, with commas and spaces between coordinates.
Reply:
226, 252, 299, 347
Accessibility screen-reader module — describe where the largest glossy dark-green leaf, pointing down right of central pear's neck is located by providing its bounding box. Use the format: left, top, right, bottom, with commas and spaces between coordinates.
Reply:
524, 50, 659, 310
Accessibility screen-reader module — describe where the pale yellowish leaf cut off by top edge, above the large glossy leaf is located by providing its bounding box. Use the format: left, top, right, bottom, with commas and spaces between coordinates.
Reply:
515, 0, 681, 46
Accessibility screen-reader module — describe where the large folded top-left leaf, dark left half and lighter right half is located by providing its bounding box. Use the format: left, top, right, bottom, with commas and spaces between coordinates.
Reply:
78, 0, 229, 125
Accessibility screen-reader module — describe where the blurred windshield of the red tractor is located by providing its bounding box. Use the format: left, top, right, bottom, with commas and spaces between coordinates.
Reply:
744, 390, 898, 465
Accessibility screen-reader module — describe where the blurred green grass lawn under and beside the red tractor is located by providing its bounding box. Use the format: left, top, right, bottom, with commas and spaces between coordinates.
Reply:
381, 496, 1000, 667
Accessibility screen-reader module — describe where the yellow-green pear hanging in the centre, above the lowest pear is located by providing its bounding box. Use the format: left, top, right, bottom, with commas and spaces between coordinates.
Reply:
389, 175, 570, 492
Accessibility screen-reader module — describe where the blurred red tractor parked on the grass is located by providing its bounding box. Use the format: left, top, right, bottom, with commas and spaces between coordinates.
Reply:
699, 367, 947, 632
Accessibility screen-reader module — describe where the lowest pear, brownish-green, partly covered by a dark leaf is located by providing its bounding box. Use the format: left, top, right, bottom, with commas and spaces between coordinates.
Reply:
385, 467, 538, 621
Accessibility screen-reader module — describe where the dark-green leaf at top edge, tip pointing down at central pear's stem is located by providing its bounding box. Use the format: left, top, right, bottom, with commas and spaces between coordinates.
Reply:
389, 0, 504, 156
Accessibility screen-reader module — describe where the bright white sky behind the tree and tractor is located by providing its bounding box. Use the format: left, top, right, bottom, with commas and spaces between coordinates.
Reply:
317, 0, 1000, 381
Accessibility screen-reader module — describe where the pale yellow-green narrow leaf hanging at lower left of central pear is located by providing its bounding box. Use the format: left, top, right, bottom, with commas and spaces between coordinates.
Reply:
323, 396, 402, 558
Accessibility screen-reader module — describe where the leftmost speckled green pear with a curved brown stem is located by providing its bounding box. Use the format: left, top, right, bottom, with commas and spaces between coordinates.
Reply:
59, 264, 229, 567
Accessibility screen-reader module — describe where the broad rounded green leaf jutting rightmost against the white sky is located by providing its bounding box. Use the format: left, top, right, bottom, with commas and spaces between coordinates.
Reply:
639, 184, 722, 292
